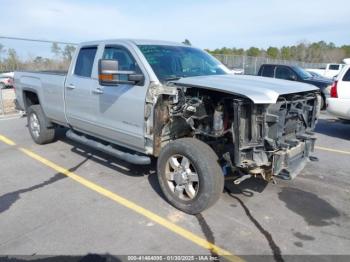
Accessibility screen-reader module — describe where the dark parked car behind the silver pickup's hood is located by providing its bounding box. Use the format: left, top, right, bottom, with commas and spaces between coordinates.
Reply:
258, 64, 333, 109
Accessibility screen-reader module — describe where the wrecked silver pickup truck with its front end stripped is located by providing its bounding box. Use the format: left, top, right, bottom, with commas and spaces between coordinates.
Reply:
14, 40, 321, 214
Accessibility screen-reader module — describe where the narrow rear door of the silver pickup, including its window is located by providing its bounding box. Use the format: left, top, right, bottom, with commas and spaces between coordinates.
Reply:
65, 46, 98, 131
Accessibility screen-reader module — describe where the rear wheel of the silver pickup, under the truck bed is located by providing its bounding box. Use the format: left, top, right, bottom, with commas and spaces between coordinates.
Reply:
27, 105, 55, 145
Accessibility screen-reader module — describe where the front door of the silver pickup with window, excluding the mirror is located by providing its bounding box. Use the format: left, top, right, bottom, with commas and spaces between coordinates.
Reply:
90, 45, 149, 152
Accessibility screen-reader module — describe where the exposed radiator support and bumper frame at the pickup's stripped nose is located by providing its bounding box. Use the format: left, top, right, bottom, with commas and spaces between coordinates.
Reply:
232, 93, 321, 183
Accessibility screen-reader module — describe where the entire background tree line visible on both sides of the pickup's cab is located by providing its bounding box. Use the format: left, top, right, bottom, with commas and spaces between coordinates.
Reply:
0, 39, 350, 71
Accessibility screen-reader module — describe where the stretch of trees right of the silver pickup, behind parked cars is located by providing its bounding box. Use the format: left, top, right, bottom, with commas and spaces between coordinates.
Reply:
206, 41, 350, 63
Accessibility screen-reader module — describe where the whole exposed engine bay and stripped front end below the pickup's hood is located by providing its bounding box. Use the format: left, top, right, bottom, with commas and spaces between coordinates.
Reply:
147, 83, 321, 184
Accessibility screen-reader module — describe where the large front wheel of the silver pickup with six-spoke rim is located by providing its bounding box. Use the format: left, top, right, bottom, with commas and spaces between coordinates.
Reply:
157, 138, 224, 215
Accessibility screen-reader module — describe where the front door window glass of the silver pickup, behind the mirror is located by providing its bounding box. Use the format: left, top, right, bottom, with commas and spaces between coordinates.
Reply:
102, 46, 138, 71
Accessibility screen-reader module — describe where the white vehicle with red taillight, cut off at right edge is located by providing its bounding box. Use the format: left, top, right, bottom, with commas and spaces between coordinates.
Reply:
327, 65, 350, 120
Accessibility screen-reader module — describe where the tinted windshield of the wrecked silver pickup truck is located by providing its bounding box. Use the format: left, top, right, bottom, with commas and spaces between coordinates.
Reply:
138, 45, 229, 81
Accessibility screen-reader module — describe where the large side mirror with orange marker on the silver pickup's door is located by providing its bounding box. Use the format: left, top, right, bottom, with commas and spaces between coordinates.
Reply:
98, 59, 145, 85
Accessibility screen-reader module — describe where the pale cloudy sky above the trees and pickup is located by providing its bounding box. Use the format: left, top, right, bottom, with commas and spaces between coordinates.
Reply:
0, 0, 350, 56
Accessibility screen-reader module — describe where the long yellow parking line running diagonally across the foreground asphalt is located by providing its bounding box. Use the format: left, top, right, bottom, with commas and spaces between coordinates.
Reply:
0, 135, 243, 261
